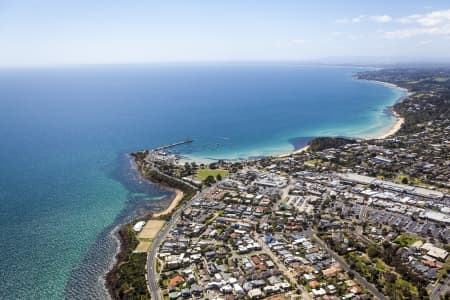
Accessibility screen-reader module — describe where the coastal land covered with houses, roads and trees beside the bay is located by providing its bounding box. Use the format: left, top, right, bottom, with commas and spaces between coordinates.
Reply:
108, 68, 450, 300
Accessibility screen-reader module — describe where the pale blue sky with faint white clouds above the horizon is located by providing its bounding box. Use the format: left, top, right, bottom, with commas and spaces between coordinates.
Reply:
0, 0, 450, 66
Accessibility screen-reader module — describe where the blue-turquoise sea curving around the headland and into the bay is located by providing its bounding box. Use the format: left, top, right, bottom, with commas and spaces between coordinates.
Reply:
0, 64, 403, 299
